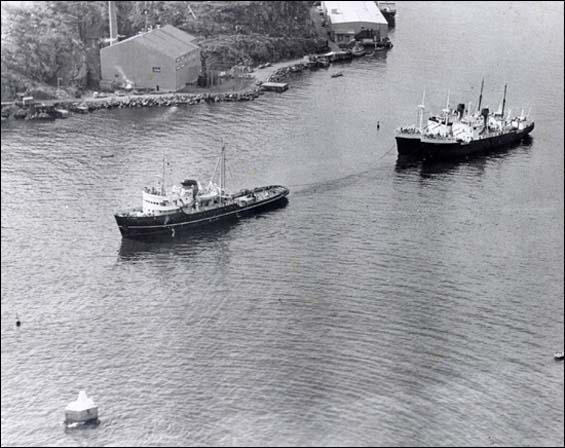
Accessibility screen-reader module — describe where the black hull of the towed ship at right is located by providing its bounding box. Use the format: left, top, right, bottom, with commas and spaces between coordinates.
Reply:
396, 123, 534, 160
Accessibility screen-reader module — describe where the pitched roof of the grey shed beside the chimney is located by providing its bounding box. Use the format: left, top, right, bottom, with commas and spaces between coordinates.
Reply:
102, 25, 198, 58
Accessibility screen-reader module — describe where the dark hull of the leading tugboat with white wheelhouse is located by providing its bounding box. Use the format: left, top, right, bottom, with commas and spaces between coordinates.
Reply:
114, 188, 289, 239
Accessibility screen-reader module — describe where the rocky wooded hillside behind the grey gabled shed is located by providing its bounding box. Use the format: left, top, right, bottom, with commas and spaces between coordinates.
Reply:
1, 1, 323, 98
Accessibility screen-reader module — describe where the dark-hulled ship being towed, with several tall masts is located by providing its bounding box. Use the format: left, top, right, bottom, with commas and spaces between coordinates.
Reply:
396, 80, 534, 159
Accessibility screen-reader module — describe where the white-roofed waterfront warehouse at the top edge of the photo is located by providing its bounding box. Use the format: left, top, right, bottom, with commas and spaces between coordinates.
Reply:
321, 1, 388, 45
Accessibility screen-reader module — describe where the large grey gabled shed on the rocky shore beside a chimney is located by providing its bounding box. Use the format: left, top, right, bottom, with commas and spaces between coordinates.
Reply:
100, 25, 201, 90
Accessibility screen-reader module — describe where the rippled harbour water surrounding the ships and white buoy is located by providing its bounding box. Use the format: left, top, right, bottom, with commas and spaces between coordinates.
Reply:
1, 2, 564, 446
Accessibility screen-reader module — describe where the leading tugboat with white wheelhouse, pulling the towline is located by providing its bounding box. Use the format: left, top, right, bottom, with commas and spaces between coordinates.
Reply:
114, 147, 289, 239
